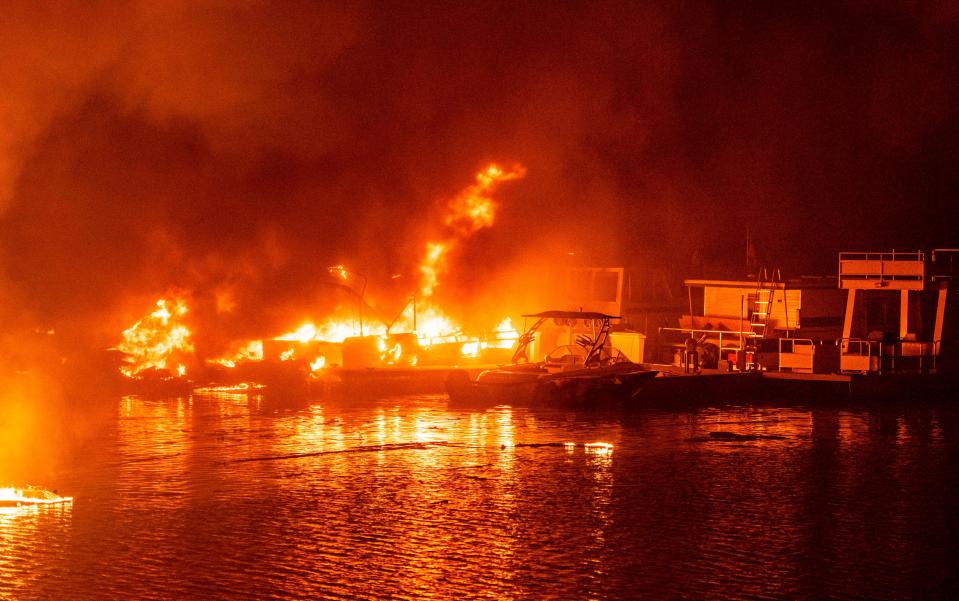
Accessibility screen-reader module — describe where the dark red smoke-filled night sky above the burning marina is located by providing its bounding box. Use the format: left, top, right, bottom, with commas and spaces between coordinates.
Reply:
0, 0, 959, 350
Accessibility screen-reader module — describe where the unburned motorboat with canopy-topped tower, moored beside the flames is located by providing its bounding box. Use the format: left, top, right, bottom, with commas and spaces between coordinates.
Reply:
446, 311, 657, 408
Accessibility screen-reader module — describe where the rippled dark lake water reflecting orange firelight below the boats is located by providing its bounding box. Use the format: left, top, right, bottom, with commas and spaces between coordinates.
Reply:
0, 393, 959, 599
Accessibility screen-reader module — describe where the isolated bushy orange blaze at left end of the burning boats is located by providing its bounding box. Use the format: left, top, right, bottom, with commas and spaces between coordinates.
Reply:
114, 298, 193, 378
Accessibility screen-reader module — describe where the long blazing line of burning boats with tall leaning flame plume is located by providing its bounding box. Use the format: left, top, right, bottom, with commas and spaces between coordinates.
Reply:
111, 164, 526, 395
